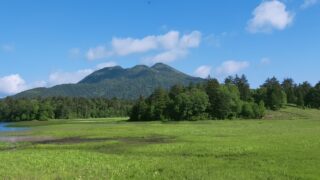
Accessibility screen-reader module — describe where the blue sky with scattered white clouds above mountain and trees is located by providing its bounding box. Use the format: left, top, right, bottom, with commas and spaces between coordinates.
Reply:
0, 0, 320, 96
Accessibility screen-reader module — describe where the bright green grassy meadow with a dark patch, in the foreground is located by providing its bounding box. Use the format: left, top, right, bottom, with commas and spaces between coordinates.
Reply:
0, 107, 320, 180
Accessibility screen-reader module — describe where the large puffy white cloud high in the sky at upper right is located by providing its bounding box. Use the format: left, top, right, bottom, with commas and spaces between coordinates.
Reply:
247, 0, 294, 33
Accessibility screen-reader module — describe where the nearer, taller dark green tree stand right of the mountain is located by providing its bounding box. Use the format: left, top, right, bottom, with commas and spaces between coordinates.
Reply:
130, 75, 320, 121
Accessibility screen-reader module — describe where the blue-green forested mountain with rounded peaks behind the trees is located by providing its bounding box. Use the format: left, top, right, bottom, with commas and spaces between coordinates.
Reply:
14, 63, 204, 99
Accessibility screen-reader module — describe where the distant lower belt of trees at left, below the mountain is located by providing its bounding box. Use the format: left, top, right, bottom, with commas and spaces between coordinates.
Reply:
0, 97, 132, 121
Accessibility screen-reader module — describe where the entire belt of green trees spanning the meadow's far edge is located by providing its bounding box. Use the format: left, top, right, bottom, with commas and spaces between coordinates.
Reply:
0, 75, 320, 121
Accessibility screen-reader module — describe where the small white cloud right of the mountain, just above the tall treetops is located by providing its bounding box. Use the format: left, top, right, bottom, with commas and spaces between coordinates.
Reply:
216, 60, 250, 75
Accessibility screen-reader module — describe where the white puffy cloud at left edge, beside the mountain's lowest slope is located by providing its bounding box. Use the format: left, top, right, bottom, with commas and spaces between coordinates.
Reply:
0, 74, 27, 95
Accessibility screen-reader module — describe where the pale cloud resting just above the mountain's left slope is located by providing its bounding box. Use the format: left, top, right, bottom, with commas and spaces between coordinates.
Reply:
48, 69, 94, 86
